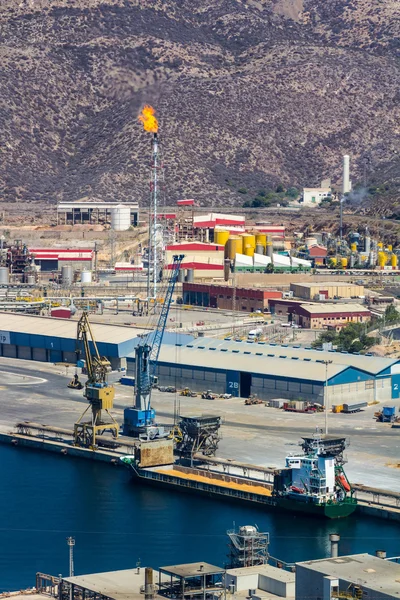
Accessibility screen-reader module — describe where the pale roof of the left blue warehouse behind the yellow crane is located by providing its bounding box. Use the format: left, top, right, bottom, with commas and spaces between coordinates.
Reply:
0, 312, 144, 344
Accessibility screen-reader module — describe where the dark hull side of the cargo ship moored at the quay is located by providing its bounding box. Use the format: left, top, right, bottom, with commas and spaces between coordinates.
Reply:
125, 465, 357, 519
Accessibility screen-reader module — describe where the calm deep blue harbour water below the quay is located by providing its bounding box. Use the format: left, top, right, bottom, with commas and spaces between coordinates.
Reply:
0, 446, 400, 592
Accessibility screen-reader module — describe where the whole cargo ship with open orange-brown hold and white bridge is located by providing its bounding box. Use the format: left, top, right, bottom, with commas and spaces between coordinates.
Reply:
121, 435, 357, 519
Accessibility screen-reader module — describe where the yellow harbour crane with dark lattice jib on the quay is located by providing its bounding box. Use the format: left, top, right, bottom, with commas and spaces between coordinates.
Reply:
74, 312, 119, 448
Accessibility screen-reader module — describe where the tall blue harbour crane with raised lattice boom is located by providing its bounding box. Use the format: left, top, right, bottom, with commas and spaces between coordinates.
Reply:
123, 254, 184, 439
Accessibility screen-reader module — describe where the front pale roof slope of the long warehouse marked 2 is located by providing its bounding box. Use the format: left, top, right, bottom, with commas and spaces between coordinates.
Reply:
159, 340, 348, 382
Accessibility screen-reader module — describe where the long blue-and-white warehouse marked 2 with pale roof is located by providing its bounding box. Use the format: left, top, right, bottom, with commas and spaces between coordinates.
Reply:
128, 338, 400, 405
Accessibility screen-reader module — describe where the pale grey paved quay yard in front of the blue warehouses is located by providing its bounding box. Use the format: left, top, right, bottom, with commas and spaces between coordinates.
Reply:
0, 358, 400, 492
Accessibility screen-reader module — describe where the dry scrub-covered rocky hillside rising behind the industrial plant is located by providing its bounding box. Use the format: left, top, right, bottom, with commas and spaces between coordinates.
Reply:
0, 0, 400, 205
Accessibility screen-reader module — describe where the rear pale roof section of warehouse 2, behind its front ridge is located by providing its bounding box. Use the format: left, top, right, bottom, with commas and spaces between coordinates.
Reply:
185, 338, 400, 375
